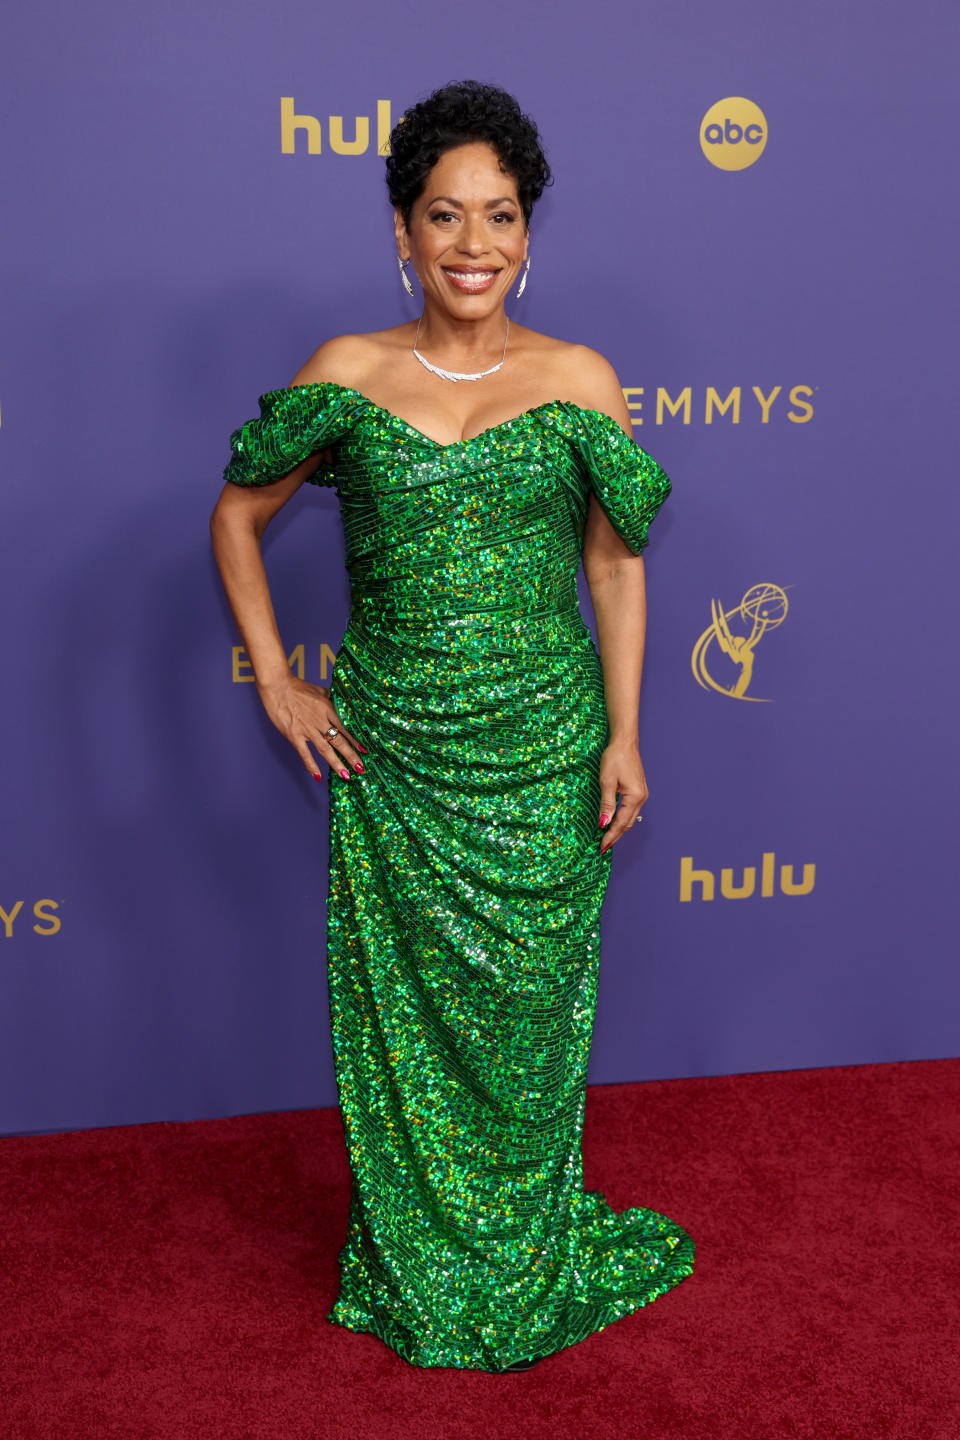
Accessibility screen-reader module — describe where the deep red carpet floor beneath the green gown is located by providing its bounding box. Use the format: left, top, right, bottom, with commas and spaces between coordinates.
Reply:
0, 1060, 960, 1440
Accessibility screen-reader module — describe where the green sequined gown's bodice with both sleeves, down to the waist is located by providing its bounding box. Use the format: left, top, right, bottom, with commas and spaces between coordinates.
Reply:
226, 383, 671, 616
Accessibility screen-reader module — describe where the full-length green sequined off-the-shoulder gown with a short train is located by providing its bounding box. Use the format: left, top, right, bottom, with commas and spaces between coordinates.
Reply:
225, 383, 694, 1371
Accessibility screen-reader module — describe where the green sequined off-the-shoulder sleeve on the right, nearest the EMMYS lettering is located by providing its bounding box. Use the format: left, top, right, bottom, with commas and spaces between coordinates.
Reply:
569, 406, 672, 554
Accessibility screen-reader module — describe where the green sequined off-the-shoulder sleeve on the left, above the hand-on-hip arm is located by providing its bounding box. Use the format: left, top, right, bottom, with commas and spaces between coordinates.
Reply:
223, 383, 363, 485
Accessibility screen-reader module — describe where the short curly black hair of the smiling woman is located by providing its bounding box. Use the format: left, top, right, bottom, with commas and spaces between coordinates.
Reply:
386, 81, 553, 225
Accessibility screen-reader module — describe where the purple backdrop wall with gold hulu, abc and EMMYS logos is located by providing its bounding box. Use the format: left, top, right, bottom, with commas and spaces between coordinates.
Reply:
0, 0, 960, 1133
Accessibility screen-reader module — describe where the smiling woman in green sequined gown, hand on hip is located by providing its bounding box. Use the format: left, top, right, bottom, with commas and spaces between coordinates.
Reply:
212, 82, 694, 1371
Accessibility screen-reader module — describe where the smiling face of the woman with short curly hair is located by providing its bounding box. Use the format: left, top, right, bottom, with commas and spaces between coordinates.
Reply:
396, 143, 528, 320
